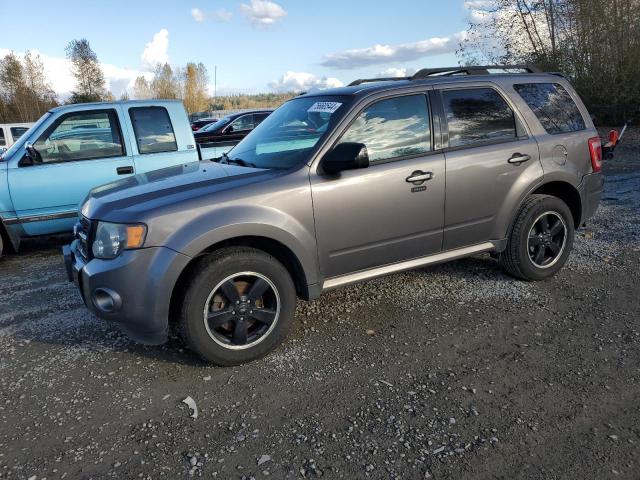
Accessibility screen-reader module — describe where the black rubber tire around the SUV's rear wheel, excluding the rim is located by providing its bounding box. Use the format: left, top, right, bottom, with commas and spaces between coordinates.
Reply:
518, 197, 575, 280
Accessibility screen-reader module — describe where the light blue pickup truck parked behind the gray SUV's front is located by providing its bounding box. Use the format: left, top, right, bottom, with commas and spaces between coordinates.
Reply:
0, 100, 198, 255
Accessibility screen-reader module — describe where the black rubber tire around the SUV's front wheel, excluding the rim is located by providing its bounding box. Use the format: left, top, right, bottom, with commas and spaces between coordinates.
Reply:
181, 251, 296, 366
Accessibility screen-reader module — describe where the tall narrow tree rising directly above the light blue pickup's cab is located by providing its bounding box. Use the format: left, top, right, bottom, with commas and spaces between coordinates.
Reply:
66, 38, 106, 103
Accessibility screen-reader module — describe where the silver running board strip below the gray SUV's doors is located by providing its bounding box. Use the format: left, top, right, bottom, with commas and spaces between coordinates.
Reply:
322, 242, 495, 292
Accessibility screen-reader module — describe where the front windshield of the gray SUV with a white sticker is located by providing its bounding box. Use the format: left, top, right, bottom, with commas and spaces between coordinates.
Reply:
220, 95, 352, 169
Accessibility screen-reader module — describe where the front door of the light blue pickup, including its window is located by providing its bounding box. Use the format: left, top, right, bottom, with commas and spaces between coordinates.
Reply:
8, 109, 134, 235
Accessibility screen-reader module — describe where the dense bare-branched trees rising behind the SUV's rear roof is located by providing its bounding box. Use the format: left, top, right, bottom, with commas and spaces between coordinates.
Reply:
459, 0, 640, 122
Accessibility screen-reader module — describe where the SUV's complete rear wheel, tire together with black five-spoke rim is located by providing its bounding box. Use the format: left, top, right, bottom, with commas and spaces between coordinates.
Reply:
499, 195, 575, 281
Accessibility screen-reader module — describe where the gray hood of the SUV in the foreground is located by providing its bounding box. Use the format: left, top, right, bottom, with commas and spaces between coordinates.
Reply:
81, 161, 277, 221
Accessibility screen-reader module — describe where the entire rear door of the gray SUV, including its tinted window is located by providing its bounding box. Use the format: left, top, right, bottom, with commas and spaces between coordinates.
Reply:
439, 84, 543, 250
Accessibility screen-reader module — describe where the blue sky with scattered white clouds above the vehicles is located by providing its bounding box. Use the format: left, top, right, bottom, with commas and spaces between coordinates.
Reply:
0, 0, 473, 95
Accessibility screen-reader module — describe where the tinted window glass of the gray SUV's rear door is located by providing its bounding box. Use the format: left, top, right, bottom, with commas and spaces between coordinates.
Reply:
442, 88, 518, 147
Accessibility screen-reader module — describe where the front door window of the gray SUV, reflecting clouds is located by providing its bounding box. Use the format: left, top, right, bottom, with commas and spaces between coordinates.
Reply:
340, 95, 431, 164
